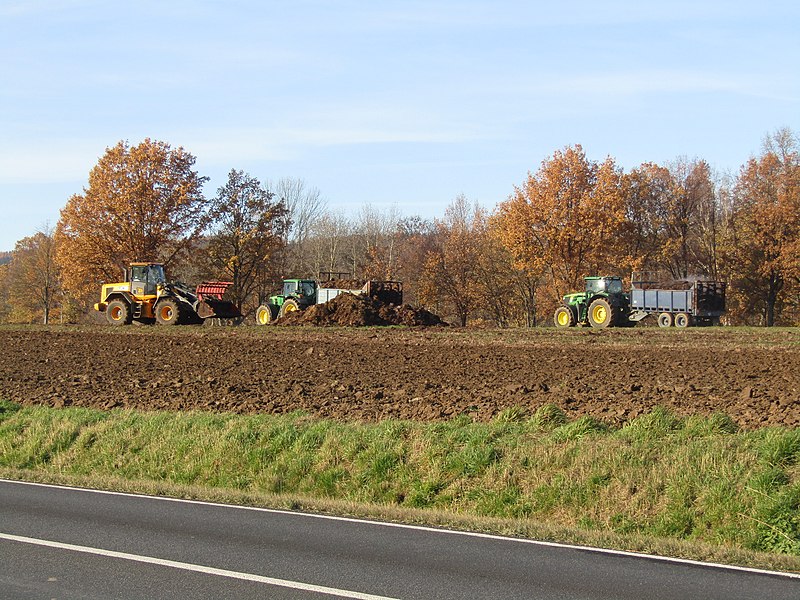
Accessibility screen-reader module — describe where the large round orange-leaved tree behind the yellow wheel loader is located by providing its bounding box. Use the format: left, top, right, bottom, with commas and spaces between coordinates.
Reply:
56, 139, 208, 308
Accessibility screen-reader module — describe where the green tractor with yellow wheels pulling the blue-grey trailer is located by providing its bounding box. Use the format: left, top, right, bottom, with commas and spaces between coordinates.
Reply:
553, 277, 630, 329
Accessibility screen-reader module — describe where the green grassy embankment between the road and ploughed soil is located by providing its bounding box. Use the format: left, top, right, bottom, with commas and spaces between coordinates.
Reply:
0, 401, 800, 571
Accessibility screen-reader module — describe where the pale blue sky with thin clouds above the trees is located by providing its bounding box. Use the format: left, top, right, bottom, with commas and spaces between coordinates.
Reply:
0, 0, 800, 251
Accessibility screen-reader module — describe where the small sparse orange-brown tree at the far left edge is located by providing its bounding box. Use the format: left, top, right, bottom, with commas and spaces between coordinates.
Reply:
7, 228, 61, 325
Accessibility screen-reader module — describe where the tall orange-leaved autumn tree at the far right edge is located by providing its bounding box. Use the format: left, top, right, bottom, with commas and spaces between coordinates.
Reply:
728, 129, 800, 327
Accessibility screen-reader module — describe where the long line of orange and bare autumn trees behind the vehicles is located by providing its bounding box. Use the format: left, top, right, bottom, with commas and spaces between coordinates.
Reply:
0, 129, 800, 326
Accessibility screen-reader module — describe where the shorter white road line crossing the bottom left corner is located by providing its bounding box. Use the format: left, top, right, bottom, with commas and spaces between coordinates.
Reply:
0, 533, 396, 600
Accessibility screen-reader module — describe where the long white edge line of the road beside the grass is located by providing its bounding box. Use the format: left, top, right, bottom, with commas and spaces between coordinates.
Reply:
0, 479, 800, 579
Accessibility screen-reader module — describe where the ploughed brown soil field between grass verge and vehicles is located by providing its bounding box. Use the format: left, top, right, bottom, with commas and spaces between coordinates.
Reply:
0, 326, 800, 428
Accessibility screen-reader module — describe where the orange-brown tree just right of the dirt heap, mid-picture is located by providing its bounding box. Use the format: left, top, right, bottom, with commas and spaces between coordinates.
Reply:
420, 195, 483, 327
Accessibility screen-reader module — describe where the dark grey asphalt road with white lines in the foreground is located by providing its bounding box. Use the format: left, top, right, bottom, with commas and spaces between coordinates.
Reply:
0, 480, 800, 600
